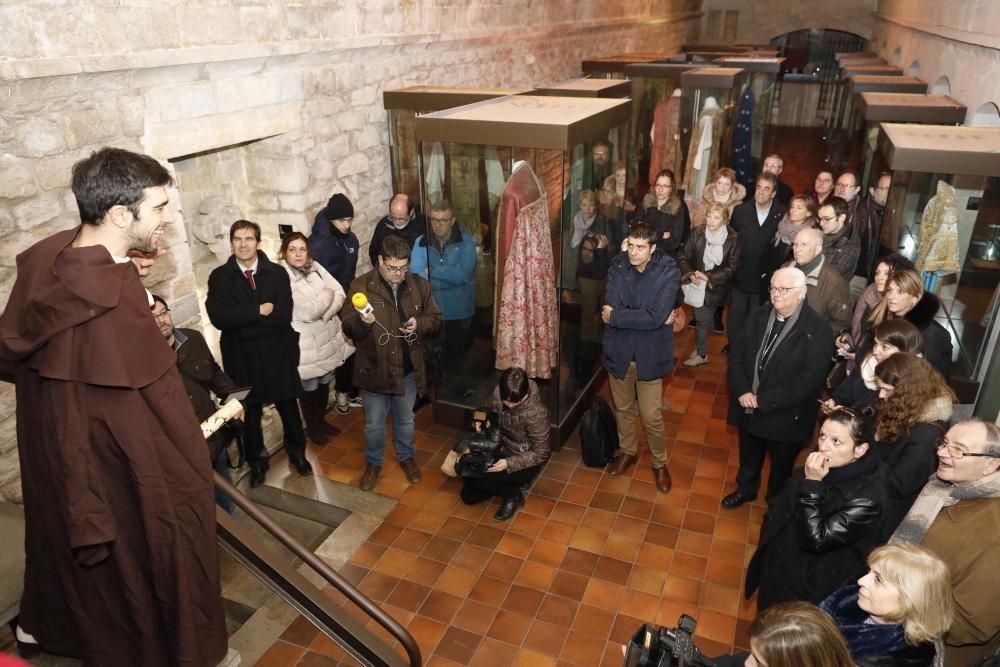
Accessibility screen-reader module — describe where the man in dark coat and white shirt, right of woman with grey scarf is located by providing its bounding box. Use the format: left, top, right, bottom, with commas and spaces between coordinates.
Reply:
729, 172, 785, 345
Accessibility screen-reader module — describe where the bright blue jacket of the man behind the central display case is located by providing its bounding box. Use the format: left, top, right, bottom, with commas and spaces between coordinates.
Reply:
410, 226, 476, 320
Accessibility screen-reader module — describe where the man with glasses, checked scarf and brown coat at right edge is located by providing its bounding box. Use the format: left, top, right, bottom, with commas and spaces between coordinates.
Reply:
890, 419, 1000, 667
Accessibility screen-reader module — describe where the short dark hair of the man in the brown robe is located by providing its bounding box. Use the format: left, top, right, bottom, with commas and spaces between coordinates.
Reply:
72, 148, 174, 225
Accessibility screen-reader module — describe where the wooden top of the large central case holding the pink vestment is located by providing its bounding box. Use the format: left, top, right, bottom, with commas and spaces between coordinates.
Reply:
416, 95, 632, 150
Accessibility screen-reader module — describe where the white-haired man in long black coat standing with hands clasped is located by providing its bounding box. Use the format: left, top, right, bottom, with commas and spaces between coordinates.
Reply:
722, 267, 833, 509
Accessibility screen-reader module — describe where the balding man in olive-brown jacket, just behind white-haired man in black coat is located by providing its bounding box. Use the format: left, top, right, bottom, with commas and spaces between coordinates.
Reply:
785, 227, 853, 335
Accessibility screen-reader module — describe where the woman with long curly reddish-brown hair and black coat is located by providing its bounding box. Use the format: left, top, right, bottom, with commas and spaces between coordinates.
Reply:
875, 352, 957, 537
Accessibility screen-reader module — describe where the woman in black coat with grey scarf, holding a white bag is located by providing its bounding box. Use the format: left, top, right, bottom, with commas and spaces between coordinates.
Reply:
678, 202, 740, 366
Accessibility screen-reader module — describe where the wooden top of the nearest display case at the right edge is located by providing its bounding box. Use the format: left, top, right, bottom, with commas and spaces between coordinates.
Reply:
879, 123, 1000, 176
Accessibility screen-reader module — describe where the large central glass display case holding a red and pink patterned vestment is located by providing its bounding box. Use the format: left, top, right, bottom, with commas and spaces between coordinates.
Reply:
411, 95, 632, 444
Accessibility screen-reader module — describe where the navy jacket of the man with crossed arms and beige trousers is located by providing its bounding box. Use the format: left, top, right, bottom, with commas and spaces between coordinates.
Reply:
604, 250, 681, 380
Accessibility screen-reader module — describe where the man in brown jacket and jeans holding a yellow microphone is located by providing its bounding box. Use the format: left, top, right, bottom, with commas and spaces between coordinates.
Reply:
343, 235, 441, 491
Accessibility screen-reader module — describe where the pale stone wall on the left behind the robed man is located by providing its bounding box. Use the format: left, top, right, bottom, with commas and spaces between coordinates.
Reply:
0, 0, 701, 499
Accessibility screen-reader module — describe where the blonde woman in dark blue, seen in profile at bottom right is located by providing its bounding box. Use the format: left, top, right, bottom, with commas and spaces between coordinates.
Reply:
820, 544, 954, 667
